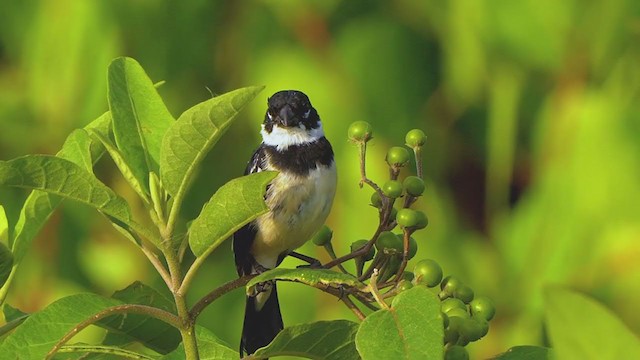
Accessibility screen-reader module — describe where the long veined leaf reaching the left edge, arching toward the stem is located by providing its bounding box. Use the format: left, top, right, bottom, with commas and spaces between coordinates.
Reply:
0, 155, 131, 223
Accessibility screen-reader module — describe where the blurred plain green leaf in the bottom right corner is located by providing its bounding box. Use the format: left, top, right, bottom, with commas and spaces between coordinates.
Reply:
544, 288, 640, 360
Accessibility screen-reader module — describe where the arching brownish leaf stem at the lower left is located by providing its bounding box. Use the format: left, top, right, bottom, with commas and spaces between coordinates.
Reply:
45, 304, 182, 359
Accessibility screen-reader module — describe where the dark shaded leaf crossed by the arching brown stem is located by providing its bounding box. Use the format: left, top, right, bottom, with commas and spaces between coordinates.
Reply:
97, 281, 181, 354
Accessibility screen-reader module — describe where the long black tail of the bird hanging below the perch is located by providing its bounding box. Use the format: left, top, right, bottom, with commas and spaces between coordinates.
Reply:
240, 283, 284, 356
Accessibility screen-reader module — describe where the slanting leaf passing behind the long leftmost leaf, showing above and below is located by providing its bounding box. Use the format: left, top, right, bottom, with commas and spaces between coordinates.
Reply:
11, 112, 111, 265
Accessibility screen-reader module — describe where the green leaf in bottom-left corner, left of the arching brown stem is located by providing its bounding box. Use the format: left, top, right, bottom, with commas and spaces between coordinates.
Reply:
0, 294, 121, 359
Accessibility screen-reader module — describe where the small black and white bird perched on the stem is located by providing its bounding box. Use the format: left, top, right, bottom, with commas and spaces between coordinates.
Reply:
233, 90, 337, 355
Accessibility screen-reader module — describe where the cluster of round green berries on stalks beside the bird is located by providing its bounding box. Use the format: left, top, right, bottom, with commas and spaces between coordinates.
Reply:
313, 121, 495, 360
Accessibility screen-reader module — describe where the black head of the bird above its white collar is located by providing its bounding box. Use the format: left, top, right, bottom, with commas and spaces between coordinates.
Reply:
264, 90, 320, 132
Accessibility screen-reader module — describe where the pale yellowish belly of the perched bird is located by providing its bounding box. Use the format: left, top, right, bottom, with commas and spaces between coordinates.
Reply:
251, 164, 336, 268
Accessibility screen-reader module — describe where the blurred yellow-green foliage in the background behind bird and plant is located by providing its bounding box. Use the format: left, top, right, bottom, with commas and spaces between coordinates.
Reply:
0, 0, 640, 358
